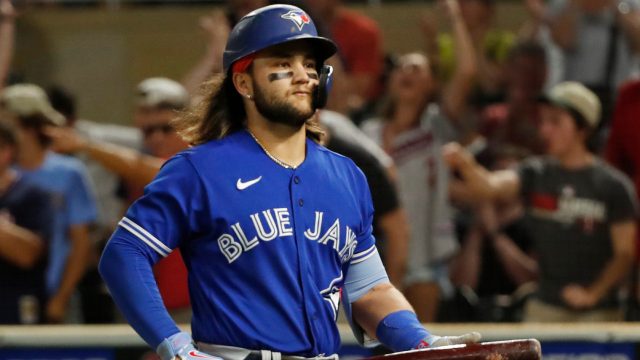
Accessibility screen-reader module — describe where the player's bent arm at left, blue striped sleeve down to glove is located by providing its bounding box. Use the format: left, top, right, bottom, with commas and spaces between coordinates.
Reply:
99, 156, 214, 360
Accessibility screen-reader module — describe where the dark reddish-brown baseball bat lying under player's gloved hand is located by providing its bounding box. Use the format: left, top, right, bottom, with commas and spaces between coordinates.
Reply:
367, 339, 542, 360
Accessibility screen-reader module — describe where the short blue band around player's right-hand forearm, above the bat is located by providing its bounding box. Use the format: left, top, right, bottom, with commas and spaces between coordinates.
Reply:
376, 310, 431, 351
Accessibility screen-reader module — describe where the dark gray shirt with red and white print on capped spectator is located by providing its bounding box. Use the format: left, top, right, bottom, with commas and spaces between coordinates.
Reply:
518, 157, 637, 308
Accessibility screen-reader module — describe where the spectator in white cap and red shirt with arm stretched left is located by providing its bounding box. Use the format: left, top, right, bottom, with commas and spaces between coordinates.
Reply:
47, 77, 191, 323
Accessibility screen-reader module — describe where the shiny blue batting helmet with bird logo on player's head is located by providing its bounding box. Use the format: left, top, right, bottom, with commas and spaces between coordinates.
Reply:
222, 4, 337, 73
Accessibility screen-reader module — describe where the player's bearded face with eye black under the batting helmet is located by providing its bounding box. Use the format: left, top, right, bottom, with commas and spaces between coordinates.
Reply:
252, 42, 318, 128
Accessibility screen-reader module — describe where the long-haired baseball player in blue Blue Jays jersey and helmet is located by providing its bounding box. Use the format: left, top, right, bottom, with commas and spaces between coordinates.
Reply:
100, 5, 480, 360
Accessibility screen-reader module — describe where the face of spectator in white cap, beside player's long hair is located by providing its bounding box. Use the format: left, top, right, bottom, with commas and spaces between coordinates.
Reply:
135, 108, 187, 159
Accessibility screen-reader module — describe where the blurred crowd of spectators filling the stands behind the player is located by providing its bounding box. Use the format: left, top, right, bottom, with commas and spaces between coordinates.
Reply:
0, 0, 640, 330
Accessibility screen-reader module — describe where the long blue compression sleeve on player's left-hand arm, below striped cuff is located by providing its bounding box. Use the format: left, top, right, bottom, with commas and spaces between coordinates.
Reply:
99, 237, 180, 349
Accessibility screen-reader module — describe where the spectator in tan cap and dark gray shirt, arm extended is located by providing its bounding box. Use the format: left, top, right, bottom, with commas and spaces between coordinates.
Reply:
445, 82, 637, 322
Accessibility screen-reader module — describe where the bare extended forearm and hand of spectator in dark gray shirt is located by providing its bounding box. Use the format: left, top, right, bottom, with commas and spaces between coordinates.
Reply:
443, 143, 521, 203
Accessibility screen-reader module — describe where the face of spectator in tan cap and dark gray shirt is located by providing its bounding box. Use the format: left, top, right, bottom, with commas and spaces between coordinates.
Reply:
539, 104, 585, 157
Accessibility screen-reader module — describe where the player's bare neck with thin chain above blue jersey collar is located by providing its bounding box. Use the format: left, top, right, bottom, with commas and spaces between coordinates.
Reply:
247, 120, 306, 168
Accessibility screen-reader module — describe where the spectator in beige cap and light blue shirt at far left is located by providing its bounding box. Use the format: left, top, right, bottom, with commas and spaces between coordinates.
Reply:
0, 84, 97, 322
